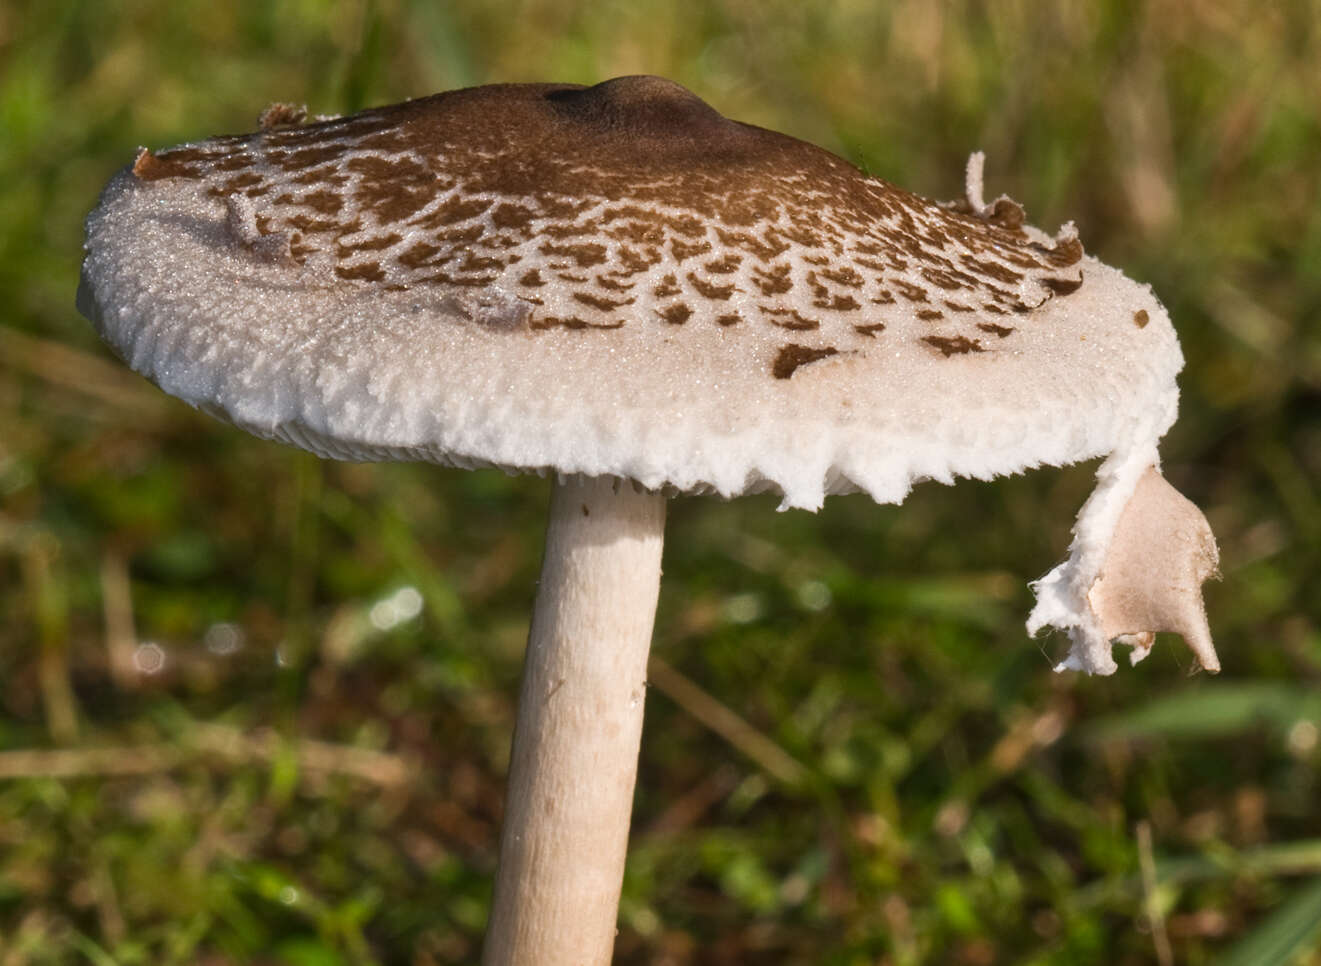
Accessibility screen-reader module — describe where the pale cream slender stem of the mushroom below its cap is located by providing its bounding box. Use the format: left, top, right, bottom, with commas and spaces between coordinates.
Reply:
482, 477, 664, 966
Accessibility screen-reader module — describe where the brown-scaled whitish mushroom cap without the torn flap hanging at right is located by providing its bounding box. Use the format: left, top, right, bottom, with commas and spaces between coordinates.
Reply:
79, 77, 1182, 507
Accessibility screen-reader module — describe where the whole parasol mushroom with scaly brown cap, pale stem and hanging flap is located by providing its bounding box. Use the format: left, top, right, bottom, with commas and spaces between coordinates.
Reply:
78, 77, 1217, 963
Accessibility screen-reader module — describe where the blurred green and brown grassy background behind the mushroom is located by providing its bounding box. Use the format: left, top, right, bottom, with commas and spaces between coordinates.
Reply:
0, 0, 1321, 966
